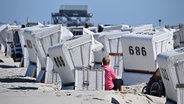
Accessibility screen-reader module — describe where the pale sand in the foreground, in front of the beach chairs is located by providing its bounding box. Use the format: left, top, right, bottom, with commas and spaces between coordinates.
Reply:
0, 52, 166, 104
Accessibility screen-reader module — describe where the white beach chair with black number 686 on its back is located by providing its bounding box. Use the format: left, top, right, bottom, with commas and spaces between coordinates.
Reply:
122, 30, 173, 73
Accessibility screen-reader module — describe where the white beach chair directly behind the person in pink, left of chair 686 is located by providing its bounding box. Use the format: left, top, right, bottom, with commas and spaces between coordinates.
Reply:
94, 30, 130, 78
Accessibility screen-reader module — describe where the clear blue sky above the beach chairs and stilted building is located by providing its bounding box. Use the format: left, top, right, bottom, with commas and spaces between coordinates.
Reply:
0, 0, 184, 26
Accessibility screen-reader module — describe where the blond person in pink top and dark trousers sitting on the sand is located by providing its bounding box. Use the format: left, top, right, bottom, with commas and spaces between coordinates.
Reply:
102, 56, 123, 91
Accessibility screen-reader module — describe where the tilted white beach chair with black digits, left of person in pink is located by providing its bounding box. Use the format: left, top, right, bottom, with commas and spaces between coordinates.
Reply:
49, 35, 104, 90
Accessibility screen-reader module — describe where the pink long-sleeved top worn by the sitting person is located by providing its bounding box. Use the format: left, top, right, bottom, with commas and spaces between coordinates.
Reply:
102, 65, 116, 90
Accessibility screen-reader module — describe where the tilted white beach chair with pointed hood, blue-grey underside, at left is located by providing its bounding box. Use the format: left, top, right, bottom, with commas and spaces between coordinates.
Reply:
24, 25, 73, 83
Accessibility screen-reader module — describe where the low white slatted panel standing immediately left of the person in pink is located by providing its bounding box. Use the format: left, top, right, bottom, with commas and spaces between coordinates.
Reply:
75, 67, 105, 90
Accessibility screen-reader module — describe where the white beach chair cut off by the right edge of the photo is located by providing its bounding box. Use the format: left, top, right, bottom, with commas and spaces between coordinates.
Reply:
157, 48, 184, 104
